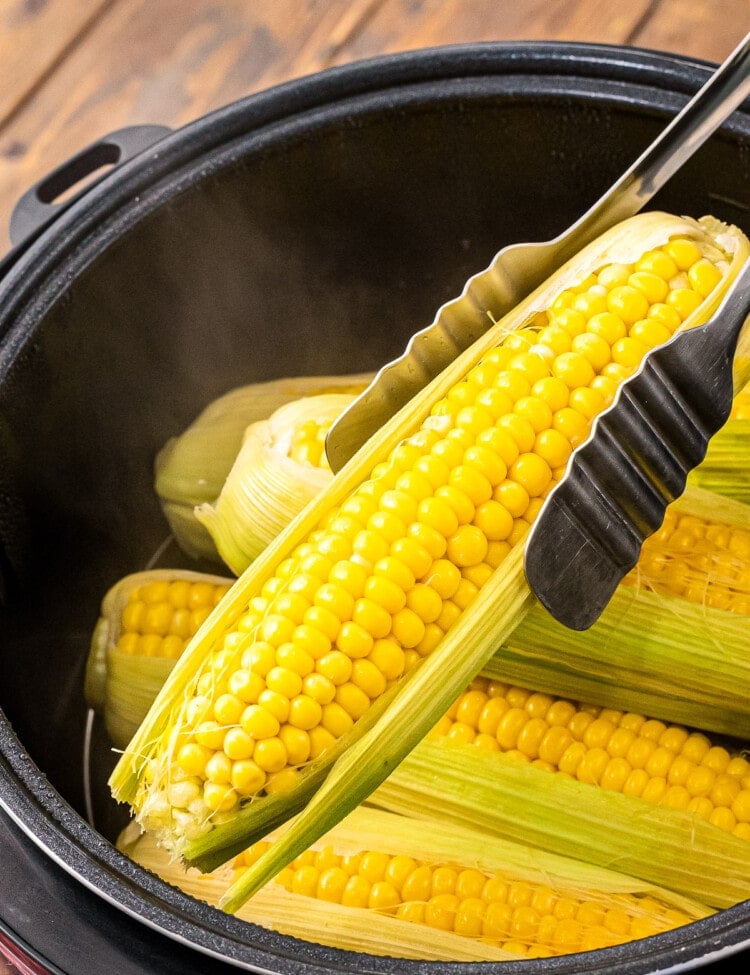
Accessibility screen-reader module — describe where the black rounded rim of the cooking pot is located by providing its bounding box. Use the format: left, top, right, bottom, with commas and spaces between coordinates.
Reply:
0, 42, 750, 975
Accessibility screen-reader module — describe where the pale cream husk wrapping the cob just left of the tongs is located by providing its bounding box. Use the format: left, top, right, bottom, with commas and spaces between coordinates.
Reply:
195, 393, 362, 575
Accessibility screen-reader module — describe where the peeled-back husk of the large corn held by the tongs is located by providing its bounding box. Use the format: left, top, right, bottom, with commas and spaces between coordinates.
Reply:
110, 212, 750, 907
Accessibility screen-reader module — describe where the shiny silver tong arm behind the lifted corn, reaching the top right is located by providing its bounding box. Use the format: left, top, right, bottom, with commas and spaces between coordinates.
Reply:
326, 34, 750, 471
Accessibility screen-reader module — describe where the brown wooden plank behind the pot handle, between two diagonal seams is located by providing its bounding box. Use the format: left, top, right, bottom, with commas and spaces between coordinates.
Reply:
0, 0, 377, 253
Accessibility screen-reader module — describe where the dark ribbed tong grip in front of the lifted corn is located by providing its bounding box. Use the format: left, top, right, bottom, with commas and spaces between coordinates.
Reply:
525, 262, 750, 630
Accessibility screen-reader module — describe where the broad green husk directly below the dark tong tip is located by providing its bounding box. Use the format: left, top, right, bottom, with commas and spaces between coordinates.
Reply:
484, 586, 750, 738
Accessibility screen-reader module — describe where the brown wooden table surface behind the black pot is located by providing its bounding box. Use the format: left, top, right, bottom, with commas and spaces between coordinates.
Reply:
0, 0, 750, 255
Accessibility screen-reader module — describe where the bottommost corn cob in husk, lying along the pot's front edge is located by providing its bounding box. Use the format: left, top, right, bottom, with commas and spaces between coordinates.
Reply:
118, 808, 709, 961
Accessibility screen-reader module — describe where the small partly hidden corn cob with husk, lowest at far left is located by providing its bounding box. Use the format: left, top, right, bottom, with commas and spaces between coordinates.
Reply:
84, 569, 233, 748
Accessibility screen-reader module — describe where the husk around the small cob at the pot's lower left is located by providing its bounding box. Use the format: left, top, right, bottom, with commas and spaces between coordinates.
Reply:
84, 569, 232, 748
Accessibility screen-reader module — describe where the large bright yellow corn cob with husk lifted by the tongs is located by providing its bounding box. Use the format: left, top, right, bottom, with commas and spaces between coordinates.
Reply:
111, 213, 747, 903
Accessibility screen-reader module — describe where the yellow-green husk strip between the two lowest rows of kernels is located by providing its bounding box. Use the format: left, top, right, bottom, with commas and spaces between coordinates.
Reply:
370, 740, 750, 908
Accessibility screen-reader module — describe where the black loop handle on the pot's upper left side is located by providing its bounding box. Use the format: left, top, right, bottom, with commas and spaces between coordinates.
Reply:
10, 125, 172, 247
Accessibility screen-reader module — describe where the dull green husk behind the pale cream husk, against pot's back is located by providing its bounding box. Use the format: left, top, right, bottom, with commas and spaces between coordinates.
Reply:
154, 373, 372, 563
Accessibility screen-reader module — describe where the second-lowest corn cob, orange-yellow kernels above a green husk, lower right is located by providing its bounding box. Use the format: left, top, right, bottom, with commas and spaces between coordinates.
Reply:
370, 677, 750, 907
